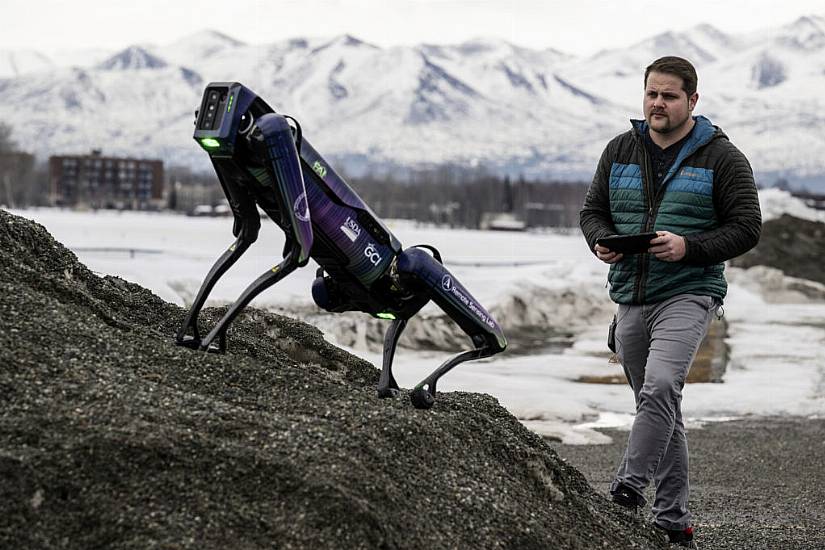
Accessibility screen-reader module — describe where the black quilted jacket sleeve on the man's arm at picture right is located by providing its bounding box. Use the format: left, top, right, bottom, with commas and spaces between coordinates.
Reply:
684, 142, 762, 265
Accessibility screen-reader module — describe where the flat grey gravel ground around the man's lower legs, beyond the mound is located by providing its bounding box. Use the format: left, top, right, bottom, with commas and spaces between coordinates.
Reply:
551, 417, 825, 550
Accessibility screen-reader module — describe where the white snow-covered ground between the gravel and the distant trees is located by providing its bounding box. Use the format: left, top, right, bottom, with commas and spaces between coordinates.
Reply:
15, 191, 825, 443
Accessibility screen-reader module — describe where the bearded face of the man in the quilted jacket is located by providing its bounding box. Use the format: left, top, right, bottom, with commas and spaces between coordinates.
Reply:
644, 71, 699, 134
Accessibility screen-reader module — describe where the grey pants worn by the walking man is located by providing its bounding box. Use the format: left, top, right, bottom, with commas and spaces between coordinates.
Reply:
611, 294, 718, 530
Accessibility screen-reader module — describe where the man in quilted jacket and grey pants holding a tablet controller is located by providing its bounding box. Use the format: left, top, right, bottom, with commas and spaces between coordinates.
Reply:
580, 57, 762, 548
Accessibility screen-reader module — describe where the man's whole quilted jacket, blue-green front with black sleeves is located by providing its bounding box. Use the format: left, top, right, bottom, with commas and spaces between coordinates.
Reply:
580, 116, 762, 304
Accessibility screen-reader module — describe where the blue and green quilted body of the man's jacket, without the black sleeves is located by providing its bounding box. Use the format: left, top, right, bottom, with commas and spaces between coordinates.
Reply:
608, 116, 727, 304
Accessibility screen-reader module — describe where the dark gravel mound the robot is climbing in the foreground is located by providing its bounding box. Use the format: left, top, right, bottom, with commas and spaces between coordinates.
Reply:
0, 211, 665, 549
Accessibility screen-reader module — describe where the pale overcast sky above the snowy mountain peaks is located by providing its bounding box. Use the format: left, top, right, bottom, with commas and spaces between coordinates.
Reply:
0, 0, 825, 55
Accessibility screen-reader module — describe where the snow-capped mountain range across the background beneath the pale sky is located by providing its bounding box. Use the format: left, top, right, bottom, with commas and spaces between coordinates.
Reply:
0, 16, 825, 183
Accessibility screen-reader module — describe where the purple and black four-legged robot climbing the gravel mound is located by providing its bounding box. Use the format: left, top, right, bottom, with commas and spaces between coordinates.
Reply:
175, 82, 507, 409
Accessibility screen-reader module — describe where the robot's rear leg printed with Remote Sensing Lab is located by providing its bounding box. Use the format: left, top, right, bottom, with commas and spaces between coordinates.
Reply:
392, 248, 507, 409
